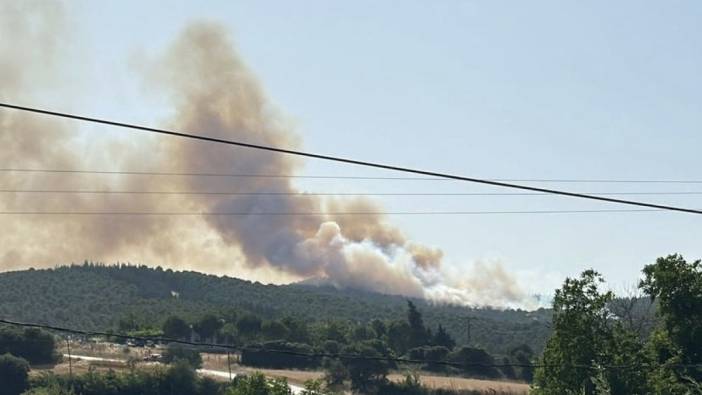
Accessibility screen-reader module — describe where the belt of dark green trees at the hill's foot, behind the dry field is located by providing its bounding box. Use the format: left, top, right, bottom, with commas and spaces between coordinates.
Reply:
135, 301, 534, 383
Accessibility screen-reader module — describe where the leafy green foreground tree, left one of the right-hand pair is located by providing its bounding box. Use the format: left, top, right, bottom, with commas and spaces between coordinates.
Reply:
533, 270, 645, 394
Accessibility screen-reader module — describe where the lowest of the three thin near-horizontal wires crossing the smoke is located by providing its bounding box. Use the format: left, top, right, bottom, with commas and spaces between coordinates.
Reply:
0, 209, 664, 217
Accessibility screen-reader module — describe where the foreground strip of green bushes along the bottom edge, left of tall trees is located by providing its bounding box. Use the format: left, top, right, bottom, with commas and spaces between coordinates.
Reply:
0, 328, 524, 395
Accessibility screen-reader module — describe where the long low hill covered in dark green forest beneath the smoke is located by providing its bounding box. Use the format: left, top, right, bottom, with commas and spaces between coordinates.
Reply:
0, 264, 550, 354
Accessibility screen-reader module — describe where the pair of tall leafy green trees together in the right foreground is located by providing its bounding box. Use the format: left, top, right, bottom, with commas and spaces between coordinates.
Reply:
533, 255, 702, 395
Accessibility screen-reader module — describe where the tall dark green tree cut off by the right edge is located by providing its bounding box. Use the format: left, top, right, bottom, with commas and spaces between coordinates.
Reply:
639, 255, 702, 394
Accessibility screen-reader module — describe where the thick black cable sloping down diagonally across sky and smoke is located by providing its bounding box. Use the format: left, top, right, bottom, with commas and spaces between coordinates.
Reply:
0, 103, 702, 214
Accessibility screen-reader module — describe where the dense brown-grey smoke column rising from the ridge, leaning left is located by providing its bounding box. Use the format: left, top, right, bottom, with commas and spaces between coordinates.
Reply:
155, 24, 524, 303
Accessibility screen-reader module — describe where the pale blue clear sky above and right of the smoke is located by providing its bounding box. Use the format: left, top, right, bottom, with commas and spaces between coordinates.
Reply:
3, 0, 702, 293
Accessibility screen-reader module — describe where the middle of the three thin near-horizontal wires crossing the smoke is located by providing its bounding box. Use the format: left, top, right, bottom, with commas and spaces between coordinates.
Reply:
0, 189, 702, 197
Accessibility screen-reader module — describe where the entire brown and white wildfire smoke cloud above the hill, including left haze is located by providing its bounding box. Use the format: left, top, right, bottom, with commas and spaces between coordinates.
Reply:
0, 5, 529, 306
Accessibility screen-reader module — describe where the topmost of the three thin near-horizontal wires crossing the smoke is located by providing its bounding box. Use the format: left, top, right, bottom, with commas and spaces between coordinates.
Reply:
0, 168, 702, 184
